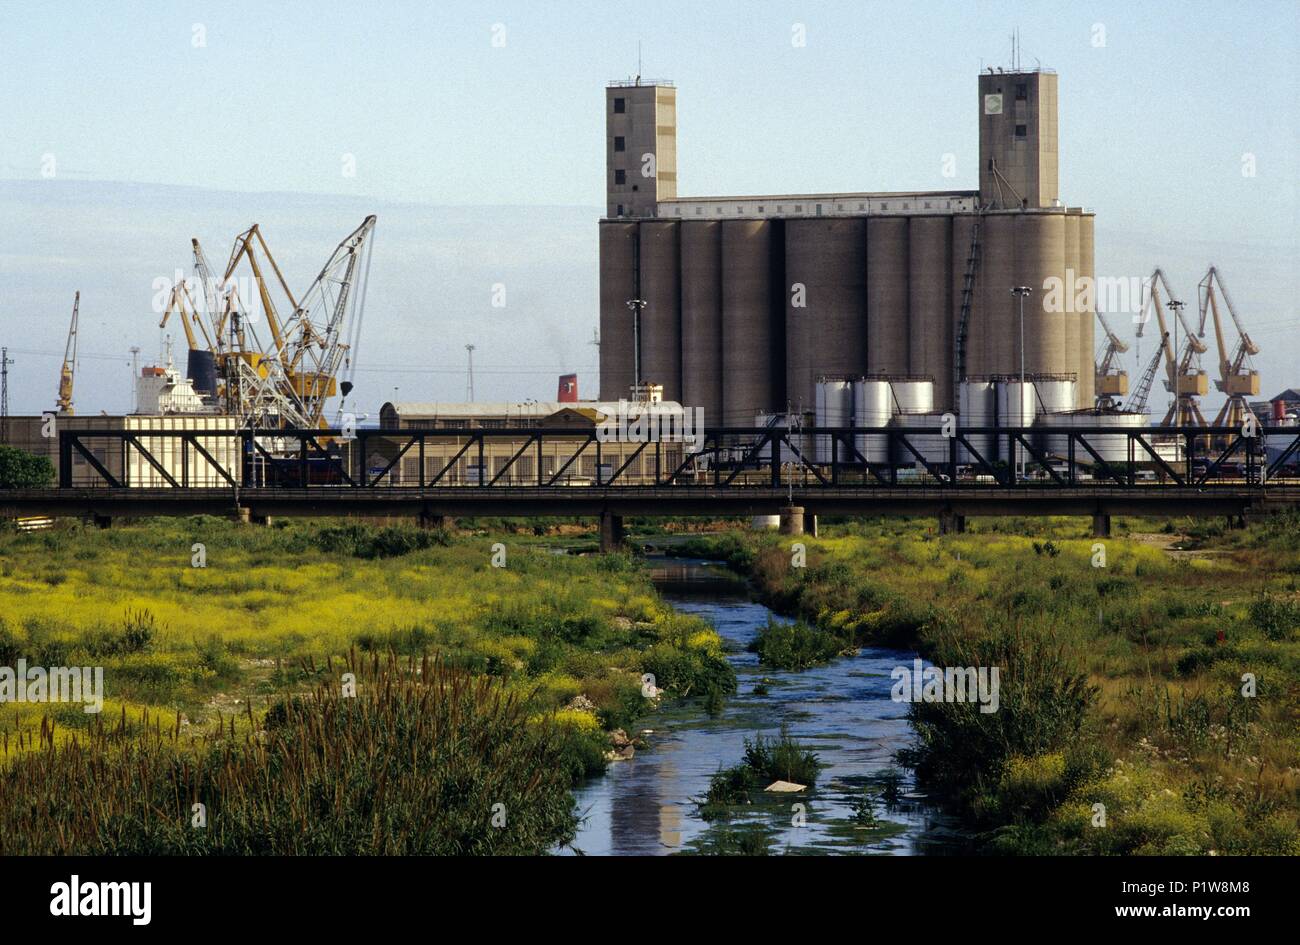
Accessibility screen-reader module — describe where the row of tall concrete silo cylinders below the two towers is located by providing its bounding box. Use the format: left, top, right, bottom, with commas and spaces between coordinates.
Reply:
601, 211, 1093, 426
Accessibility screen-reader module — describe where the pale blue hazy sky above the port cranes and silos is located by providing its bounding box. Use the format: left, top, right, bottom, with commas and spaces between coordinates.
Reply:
0, 0, 1300, 412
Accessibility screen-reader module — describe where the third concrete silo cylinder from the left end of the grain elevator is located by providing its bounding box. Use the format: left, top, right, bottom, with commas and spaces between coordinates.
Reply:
681, 221, 723, 428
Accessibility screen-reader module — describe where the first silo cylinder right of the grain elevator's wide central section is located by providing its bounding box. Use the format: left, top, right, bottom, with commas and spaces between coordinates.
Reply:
867, 217, 911, 374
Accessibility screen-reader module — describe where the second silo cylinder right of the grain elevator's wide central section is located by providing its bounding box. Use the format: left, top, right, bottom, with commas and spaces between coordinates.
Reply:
907, 214, 961, 409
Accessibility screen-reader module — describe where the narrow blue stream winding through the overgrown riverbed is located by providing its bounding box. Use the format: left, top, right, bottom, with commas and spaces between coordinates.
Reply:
573, 556, 961, 855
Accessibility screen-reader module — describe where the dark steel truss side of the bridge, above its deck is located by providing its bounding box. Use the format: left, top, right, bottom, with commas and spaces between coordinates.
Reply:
59, 421, 1300, 490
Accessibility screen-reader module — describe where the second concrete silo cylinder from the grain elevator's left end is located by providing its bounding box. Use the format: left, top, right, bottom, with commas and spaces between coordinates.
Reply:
629, 221, 681, 402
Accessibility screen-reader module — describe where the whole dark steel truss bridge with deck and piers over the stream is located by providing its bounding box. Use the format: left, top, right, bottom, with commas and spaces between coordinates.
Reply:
0, 425, 1300, 543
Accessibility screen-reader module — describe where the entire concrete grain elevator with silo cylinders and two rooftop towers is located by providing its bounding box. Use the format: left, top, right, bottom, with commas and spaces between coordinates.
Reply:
599, 69, 1095, 426
